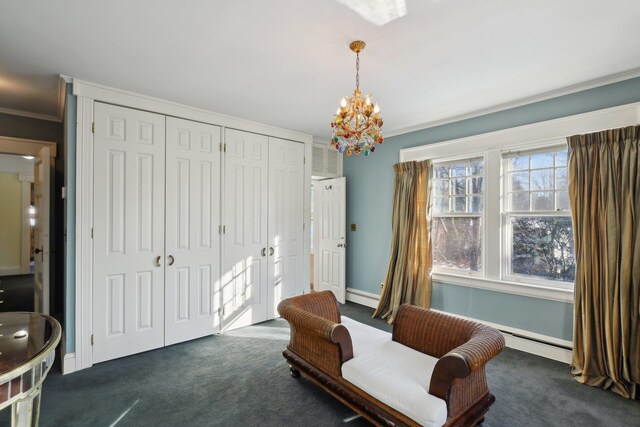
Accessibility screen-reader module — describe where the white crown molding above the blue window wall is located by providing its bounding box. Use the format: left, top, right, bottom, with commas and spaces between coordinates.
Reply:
383, 68, 640, 138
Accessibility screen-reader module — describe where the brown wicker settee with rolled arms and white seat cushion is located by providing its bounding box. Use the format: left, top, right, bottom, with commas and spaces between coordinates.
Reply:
278, 291, 504, 426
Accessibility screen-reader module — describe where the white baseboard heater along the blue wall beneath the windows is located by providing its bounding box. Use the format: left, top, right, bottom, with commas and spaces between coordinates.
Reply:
347, 288, 573, 364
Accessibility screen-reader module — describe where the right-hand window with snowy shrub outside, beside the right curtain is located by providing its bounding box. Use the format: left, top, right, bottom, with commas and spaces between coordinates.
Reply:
503, 147, 575, 285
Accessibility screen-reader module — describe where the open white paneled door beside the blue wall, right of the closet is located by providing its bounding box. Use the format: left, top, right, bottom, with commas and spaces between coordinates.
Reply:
313, 178, 347, 304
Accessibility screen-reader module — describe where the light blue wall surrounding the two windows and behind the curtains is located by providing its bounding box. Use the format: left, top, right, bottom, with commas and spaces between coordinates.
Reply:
344, 78, 640, 340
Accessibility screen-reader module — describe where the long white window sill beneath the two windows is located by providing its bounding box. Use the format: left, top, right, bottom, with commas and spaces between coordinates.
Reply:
431, 273, 573, 304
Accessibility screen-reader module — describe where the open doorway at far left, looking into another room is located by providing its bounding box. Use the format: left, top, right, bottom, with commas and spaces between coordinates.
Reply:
0, 137, 55, 314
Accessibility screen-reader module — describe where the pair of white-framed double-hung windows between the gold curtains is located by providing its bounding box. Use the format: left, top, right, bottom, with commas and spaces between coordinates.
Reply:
430, 142, 575, 289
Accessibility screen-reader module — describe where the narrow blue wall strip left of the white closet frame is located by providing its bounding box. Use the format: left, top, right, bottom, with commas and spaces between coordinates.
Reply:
64, 83, 77, 353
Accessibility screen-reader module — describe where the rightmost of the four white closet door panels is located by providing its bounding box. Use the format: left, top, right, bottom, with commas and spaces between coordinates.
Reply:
267, 138, 307, 318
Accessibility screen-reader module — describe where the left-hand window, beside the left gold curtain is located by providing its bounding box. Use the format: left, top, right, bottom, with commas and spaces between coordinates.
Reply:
431, 158, 484, 272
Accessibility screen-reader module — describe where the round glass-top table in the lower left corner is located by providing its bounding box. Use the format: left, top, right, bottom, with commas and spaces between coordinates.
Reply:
0, 313, 62, 427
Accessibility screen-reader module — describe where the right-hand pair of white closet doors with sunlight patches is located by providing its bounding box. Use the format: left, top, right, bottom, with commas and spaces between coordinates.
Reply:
222, 129, 304, 329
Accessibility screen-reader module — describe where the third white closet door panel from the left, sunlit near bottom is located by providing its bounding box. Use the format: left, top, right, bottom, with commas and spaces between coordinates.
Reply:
222, 129, 269, 329
